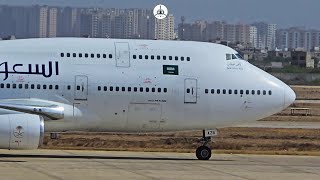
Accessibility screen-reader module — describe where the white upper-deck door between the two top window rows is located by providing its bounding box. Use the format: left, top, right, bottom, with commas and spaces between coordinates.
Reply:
115, 42, 130, 67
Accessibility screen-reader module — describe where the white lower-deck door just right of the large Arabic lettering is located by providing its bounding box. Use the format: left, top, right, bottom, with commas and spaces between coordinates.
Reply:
74, 76, 88, 101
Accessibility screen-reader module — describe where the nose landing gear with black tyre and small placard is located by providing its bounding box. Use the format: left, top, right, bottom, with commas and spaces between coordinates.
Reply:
196, 129, 218, 160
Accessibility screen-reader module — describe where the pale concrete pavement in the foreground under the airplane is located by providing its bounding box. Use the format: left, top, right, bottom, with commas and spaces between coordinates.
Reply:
0, 150, 320, 180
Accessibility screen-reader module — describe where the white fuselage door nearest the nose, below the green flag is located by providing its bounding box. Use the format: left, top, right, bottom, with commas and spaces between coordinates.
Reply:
184, 79, 198, 104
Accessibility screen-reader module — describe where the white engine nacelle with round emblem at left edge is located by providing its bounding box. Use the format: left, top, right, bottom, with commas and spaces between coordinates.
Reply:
0, 114, 44, 149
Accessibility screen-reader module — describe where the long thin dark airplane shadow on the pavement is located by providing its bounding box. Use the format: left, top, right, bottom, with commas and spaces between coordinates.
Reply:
0, 154, 233, 162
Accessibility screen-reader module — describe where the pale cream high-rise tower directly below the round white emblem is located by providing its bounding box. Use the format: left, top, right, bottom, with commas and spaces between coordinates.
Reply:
155, 14, 175, 40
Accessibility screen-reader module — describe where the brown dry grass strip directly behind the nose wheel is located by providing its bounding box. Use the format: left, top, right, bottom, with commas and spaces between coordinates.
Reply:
43, 128, 320, 155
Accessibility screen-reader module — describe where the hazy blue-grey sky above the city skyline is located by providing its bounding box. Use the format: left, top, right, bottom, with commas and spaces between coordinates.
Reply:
0, 0, 320, 29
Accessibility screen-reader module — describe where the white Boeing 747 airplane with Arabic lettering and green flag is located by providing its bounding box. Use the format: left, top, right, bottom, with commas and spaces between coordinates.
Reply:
0, 38, 296, 160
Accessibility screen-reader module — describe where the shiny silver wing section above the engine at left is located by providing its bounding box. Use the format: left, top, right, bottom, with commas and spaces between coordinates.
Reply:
0, 99, 64, 120
